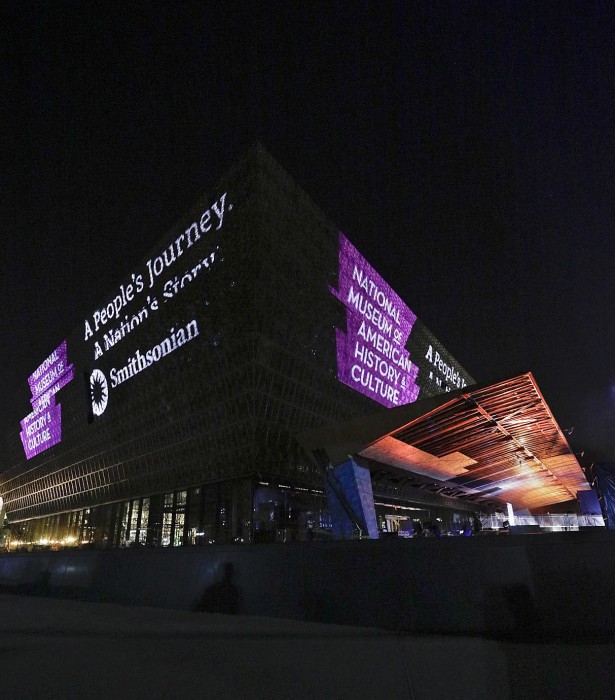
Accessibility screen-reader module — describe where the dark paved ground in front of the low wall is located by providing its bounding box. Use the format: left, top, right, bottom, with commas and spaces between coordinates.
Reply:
0, 595, 615, 700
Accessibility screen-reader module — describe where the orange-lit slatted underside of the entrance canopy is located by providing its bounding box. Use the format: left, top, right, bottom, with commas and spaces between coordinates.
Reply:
358, 373, 589, 509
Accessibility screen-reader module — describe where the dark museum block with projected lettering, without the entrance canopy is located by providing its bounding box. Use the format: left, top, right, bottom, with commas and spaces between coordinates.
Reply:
0, 146, 473, 546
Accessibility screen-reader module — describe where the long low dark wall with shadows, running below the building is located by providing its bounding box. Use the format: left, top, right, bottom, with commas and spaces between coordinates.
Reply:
0, 530, 615, 636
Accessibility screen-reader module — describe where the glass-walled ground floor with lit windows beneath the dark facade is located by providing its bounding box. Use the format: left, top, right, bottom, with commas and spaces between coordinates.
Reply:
4, 479, 496, 550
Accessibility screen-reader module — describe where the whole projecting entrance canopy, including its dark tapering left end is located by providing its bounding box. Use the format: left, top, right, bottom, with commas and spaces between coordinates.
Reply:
299, 373, 590, 509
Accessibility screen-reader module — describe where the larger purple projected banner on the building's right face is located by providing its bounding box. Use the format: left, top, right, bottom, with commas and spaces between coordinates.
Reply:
329, 233, 419, 408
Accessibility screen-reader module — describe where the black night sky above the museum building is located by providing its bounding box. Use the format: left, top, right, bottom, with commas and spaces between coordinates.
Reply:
0, 0, 615, 468
